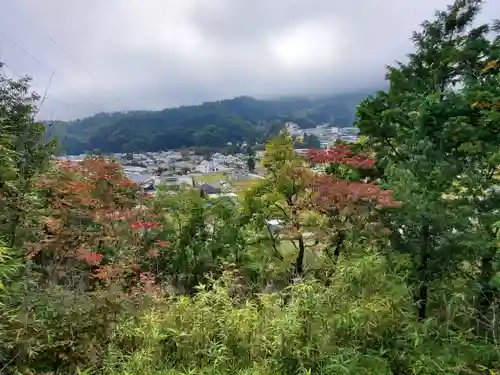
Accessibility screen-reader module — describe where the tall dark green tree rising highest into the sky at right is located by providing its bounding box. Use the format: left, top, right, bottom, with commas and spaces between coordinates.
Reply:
357, 0, 494, 319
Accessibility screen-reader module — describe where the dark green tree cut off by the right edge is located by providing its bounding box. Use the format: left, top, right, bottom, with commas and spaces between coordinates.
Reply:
456, 27, 500, 322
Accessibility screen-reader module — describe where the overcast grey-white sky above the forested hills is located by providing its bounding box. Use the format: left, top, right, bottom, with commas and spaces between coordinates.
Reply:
0, 0, 500, 119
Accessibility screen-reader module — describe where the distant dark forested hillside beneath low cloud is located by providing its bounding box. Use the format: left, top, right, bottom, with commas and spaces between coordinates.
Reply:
49, 92, 370, 154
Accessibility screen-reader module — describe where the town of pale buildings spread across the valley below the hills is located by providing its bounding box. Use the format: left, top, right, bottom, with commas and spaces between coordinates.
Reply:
59, 122, 359, 198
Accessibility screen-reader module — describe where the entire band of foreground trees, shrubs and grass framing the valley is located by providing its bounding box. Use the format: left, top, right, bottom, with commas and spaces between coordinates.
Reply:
0, 0, 500, 375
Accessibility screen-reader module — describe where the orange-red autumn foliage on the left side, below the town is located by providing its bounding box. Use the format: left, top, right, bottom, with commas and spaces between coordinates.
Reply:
27, 158, 158, 290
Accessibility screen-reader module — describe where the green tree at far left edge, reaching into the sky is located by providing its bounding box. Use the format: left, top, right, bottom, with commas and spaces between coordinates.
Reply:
0, 69, 55, 247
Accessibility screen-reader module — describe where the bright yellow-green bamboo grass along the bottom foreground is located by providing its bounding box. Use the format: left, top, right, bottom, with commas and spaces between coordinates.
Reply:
99, 254, 499, 375
